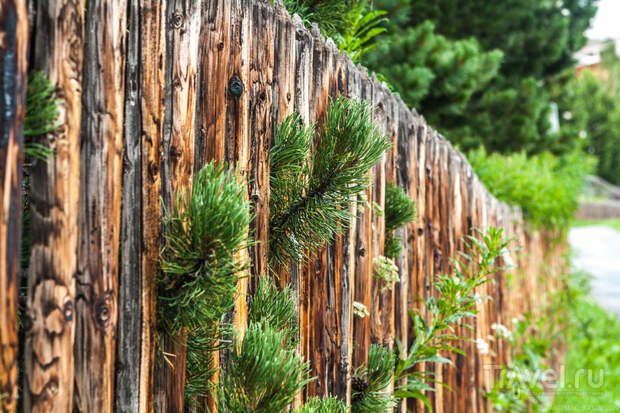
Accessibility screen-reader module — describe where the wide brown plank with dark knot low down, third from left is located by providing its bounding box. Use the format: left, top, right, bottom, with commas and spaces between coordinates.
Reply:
73, 0, 126, 412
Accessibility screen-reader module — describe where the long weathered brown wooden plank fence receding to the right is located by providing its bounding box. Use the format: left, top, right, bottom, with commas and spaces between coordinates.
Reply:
0, 0, 561, 413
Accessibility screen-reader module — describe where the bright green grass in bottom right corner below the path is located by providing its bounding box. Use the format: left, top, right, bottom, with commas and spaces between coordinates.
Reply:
551, 298, 620, 413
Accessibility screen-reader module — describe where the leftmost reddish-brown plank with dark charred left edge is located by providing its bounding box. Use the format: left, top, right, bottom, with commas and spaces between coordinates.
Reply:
0, 0, 28, 413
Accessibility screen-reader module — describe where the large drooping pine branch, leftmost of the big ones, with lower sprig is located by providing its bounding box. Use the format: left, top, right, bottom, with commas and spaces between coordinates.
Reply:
157, 163, 250, 398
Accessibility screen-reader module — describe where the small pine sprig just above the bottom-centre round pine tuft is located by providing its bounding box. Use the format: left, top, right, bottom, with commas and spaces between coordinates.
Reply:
248, 276, 299, 348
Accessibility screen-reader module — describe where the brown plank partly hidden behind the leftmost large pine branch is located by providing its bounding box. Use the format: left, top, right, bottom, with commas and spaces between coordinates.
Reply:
154, 0, 201, 412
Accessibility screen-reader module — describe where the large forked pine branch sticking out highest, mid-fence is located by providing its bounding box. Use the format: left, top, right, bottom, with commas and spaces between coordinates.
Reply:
269, 98, 390, 266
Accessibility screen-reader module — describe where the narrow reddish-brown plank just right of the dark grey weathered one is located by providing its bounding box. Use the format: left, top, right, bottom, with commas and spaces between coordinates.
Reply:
139, 0, 166, 412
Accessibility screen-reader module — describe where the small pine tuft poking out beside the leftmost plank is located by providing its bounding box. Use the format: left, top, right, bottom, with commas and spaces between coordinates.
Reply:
24, 71, 60, 160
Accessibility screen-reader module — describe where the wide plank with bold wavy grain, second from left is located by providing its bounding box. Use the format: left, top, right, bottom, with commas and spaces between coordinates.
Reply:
24, 1, 84, 412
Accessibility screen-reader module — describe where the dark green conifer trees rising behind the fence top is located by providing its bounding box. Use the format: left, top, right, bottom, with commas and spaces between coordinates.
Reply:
366, 0, 596, 153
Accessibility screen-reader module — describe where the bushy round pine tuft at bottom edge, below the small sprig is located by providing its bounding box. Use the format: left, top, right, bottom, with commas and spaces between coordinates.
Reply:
218, 323, 311, 413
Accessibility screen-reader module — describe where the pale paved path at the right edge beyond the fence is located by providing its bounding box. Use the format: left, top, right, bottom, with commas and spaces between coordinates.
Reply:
568, 225, 620, 316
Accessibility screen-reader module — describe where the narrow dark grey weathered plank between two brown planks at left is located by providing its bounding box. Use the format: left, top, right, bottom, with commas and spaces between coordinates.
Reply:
115, 0, 143, 413
